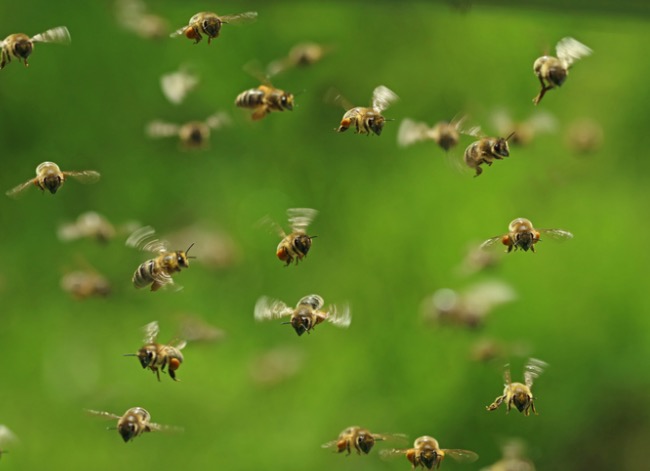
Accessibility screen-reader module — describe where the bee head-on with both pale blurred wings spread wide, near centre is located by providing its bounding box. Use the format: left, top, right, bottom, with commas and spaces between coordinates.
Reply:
255, 294, 352, 336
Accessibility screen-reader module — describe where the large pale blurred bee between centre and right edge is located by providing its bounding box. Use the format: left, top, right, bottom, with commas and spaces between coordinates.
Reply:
422, 280, 517, 328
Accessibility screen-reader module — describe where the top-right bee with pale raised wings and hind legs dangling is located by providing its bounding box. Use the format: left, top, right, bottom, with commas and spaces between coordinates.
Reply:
533, 38, 593, 105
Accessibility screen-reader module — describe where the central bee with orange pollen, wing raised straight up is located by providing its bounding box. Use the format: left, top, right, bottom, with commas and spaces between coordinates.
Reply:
260, 208, 318, 266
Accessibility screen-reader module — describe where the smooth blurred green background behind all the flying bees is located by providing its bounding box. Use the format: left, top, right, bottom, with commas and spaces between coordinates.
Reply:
0, 0, 650, 470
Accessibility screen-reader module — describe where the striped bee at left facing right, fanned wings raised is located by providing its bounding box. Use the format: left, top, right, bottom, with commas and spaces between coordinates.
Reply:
126, 226, 194, 291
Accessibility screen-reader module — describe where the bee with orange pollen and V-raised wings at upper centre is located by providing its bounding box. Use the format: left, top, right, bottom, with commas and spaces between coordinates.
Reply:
335, 85, 399, 136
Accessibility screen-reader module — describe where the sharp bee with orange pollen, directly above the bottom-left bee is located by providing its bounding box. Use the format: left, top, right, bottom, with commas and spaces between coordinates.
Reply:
124, 321, 187, 381
